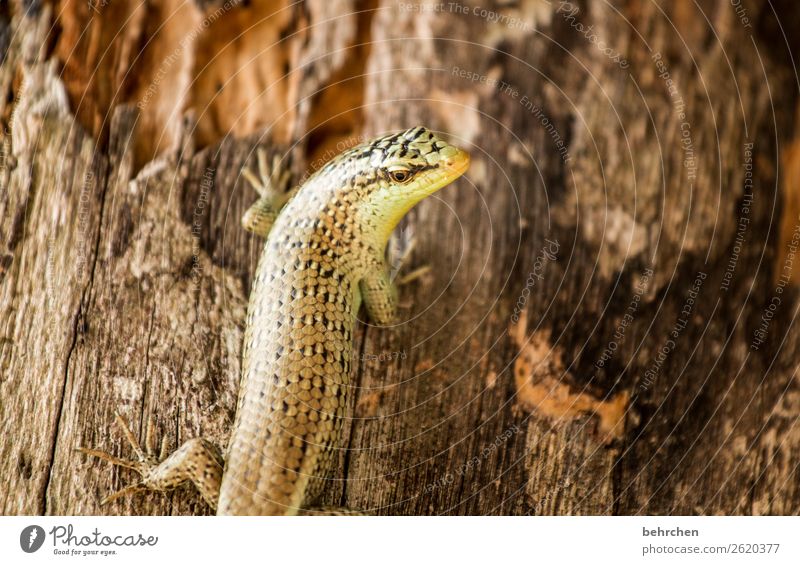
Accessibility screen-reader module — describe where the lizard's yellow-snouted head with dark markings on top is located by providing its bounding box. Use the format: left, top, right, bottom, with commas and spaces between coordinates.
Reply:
350, 126, 469, 240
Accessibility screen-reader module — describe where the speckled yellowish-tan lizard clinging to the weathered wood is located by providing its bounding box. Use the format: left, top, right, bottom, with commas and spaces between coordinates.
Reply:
78, 126, 470, 515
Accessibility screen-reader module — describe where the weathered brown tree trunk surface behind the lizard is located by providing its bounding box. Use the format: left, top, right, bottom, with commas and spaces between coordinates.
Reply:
0, 0, 800, 514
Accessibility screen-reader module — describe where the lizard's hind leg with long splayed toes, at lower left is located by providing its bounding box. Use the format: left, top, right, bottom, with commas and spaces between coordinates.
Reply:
77, 414, 224, 510
